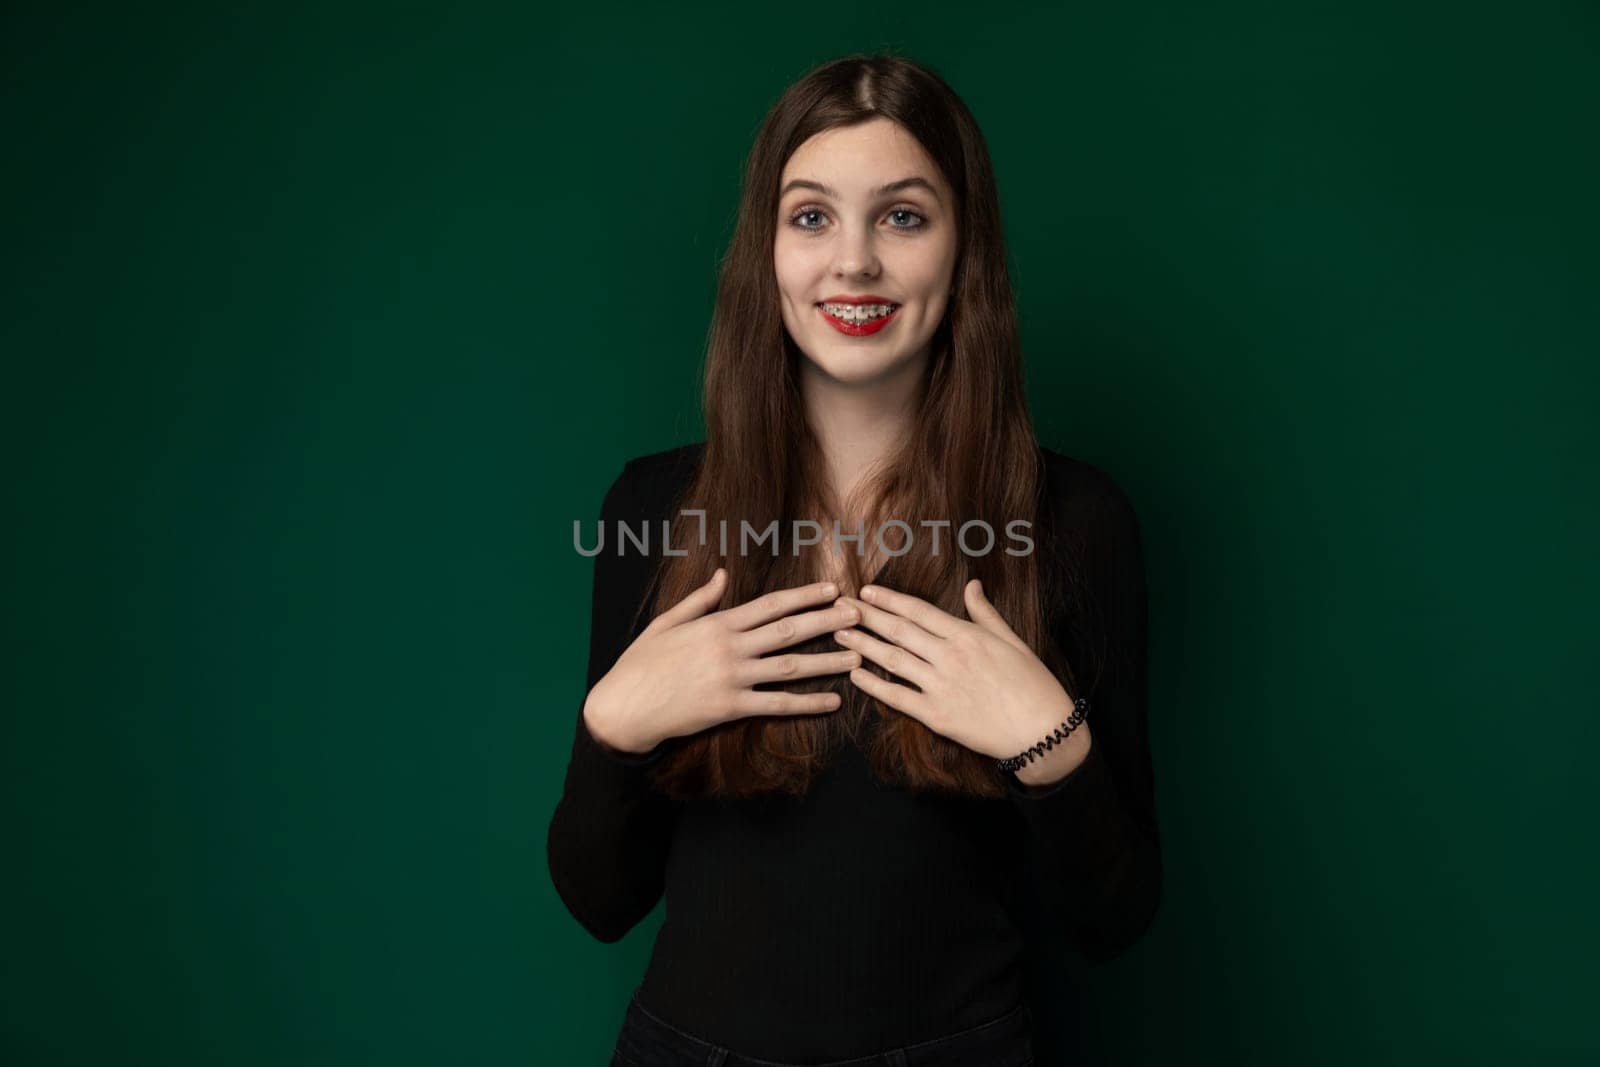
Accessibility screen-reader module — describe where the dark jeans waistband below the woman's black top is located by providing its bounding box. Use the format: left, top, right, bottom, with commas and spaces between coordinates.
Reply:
611, 992, 1034, 1067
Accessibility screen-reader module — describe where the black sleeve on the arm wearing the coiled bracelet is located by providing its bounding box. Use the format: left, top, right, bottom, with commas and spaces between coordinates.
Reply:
1006, 475, 1162, 963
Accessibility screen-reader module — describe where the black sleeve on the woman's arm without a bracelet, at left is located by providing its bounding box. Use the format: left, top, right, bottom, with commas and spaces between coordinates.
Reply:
546, 462, 677, 944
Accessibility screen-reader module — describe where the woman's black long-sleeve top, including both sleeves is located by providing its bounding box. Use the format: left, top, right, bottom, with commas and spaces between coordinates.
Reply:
547, 443, 1162, 1061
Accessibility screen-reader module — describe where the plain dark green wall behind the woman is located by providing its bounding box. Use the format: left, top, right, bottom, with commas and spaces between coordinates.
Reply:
0, 2, 1600, 1065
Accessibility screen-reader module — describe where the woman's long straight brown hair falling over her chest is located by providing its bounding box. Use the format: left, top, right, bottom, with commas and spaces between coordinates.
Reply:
645, 54, 1067, 798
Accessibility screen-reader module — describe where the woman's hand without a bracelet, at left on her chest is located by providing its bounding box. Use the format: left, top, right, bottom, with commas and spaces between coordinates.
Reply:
584, 566, 861, 755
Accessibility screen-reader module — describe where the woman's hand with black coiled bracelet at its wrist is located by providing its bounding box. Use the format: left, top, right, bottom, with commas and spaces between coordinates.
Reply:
834, 579, 1090, 781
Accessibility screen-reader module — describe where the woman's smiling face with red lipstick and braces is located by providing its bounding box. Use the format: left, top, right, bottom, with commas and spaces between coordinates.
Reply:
773, 118, 957, 384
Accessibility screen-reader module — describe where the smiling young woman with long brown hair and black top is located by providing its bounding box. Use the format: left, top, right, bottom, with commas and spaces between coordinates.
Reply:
549, 56, 1162, 1067
